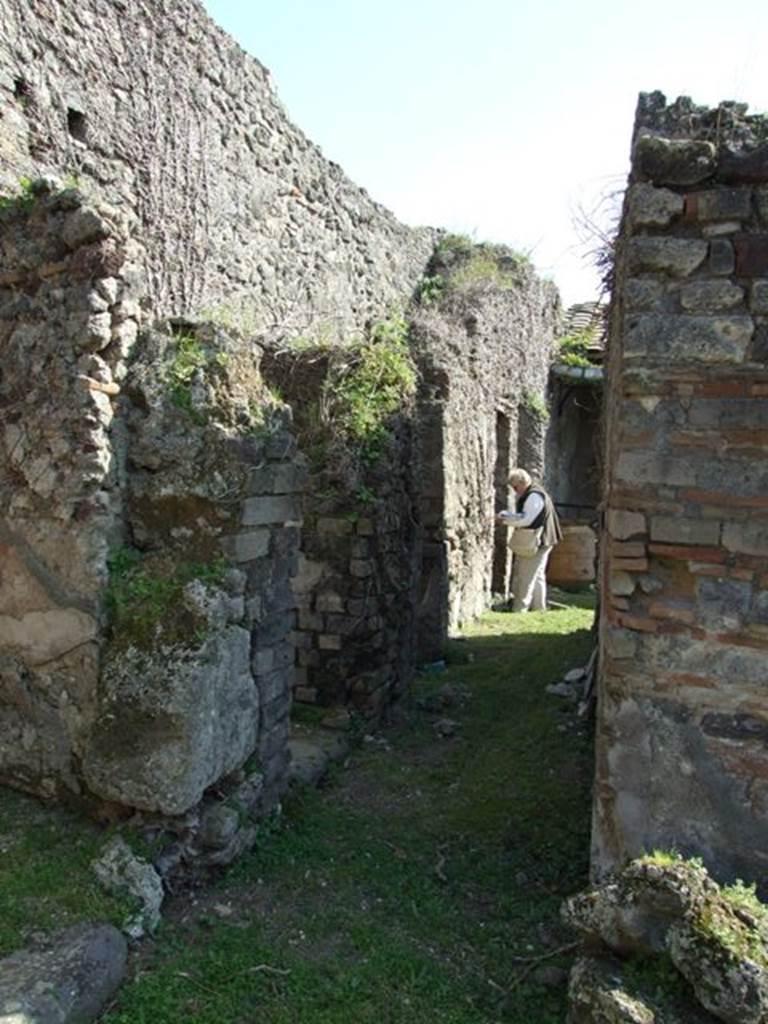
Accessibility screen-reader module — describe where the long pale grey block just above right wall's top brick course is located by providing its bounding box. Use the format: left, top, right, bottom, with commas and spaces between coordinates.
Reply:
625, 313, 755, 362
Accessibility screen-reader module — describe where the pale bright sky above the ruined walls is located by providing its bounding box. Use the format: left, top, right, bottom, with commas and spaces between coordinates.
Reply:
199, 0, 768, 304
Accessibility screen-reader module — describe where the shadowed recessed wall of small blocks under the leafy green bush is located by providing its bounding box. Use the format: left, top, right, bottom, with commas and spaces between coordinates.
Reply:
265, 346, 421, 715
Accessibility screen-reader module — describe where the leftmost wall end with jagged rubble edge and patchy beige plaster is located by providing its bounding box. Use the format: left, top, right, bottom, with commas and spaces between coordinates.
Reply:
0, 194, 140, 795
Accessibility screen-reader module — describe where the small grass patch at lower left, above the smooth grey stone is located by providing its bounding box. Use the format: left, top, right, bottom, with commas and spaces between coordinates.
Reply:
0, 790, 133, 956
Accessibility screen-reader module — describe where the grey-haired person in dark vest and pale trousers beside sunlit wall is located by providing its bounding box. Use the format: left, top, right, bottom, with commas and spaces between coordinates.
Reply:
497, 469, 562, 611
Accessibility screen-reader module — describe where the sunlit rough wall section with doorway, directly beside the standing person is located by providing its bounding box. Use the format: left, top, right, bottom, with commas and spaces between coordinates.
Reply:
413, 247, 560, 659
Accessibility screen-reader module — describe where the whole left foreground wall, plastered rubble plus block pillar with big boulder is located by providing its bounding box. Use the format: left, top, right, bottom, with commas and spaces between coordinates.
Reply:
0, 186, 303, 839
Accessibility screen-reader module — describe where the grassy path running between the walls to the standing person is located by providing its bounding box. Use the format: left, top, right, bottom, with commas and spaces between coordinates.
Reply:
104, 599, 592, 1024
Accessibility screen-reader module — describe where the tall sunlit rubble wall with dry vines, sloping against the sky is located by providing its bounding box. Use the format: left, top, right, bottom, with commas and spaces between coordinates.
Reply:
0, 0, 432, 327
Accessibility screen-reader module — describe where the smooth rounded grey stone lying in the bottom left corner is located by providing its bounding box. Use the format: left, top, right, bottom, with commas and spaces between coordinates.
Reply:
0, 924, 128, 1024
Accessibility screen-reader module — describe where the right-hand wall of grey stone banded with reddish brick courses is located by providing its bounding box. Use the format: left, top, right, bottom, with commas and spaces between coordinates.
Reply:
594, 93, 768, 880
